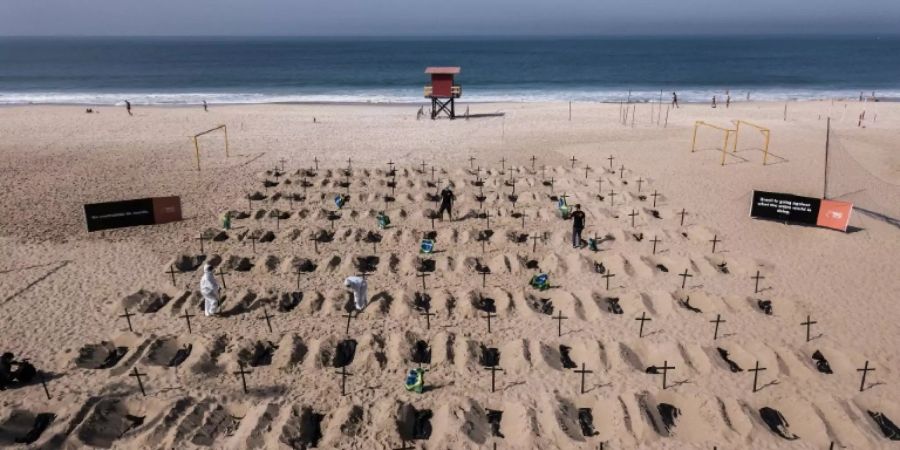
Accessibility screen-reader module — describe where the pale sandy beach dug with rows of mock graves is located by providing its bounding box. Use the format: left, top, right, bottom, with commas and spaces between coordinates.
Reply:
0, 100, 900, 449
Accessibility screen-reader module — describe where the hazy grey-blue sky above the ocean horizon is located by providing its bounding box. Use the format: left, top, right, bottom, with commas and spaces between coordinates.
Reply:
0, 0, 900, 36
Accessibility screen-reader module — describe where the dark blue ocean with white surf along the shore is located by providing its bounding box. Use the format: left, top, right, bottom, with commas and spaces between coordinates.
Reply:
0, 36, 900, 104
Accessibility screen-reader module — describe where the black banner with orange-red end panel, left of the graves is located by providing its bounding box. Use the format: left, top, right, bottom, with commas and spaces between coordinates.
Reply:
84, 197, 181, 232
